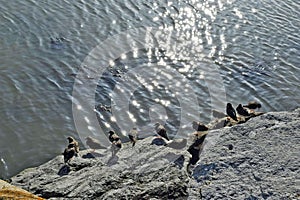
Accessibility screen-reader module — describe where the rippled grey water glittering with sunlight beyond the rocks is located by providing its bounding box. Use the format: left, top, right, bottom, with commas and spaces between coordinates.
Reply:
0, 0, 300, 178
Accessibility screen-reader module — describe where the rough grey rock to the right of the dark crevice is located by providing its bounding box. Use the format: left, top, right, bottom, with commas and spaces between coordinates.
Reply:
193, 109, 300, 199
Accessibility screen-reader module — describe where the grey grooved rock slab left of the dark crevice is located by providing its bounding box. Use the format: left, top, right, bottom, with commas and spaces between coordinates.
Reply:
12, 138, 190, 199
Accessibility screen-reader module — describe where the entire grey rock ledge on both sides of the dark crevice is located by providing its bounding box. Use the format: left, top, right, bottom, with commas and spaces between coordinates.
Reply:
11, 109, 300, 200
